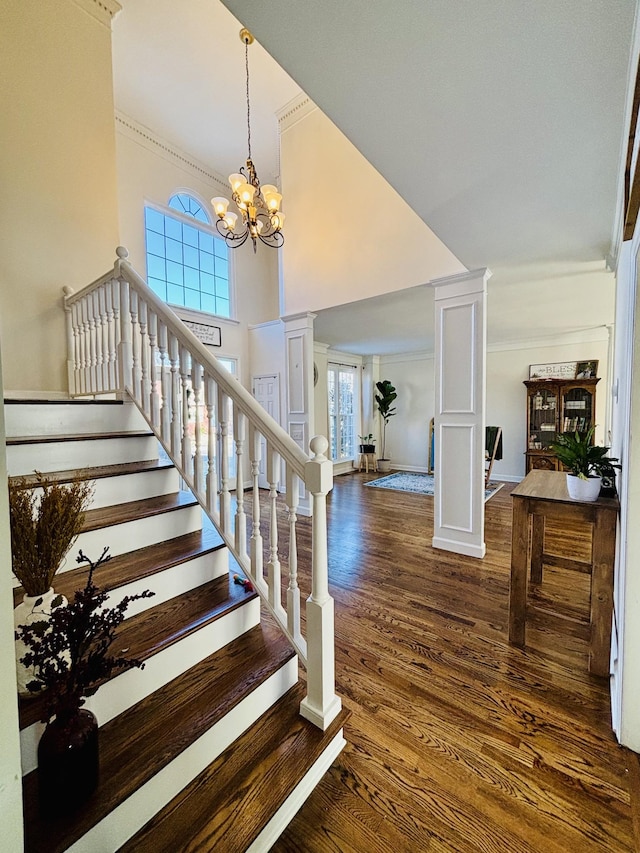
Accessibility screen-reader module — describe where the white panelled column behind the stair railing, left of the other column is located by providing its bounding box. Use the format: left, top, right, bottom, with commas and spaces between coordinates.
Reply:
281, 312, 316, 516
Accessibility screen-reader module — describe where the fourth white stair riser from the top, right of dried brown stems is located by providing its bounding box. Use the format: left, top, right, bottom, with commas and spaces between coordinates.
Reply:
59, 504, 202, 568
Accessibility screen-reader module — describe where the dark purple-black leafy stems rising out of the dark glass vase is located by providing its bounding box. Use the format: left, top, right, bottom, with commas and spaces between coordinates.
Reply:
16, 548, 155, 723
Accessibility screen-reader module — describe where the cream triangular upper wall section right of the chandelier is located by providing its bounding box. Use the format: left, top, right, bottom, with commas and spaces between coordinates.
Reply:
281, 100, 464, 314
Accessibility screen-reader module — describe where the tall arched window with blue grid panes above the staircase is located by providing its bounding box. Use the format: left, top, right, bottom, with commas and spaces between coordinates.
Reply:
144, 193, 231, 317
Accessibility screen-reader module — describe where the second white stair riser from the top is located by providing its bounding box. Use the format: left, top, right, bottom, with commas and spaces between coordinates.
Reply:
7, 435, 158, 476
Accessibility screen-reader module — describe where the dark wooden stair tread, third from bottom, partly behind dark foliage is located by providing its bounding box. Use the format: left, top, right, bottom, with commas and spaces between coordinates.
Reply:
19, 574, 248, 729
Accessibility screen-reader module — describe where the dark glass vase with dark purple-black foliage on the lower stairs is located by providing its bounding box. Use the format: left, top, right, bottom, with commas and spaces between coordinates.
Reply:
16, 548, 154, 816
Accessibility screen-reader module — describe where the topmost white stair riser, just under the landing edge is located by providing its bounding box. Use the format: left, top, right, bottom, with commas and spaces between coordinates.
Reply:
4, 402, 147, 438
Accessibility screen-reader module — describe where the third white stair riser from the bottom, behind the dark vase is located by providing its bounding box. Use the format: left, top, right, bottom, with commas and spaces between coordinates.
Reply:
20, 598, 260, 776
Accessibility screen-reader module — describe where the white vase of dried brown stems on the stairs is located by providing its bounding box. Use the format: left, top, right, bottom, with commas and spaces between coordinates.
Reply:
9, 472, 93, 696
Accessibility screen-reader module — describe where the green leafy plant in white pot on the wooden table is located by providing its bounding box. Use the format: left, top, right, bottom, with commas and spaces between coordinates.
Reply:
551, 426, 616, 501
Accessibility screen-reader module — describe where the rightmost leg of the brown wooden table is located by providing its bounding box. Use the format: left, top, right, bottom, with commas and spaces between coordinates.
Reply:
589, 510, 617, 676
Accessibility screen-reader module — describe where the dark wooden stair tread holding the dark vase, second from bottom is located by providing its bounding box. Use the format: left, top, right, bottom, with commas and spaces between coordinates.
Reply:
23, 626, 295, 853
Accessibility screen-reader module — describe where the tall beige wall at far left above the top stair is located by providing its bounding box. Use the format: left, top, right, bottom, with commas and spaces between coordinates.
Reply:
0, 0, 118, 392
